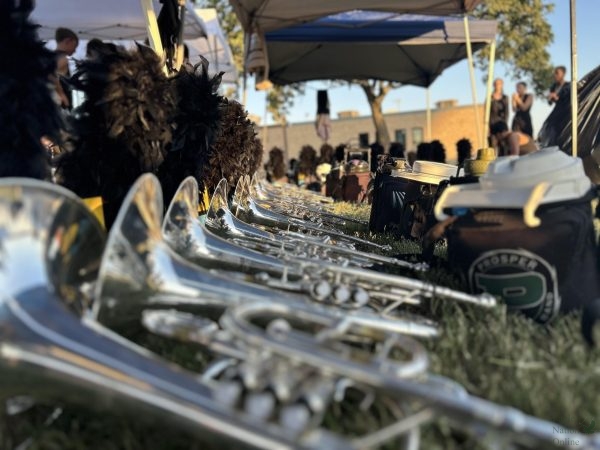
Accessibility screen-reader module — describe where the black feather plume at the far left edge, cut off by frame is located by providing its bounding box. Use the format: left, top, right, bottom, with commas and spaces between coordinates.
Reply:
0, 0, 62, 179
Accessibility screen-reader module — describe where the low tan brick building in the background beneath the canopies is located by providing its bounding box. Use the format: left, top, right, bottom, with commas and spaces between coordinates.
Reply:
258, 100, 484, 162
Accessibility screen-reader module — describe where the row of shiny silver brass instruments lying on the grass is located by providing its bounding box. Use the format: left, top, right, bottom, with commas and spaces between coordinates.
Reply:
0, 174, 600, 449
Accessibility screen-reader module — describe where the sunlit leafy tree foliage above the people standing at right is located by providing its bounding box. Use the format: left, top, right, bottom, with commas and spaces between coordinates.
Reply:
473, 0, 554, 95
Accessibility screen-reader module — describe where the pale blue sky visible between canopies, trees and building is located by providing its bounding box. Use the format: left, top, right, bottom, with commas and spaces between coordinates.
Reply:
241, 0, 600, 138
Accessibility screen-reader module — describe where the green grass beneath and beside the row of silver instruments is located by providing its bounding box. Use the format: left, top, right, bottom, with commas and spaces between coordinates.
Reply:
0, 204, 600, 450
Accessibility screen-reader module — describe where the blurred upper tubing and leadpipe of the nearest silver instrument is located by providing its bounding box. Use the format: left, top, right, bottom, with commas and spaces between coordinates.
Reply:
221, 303, 600, 450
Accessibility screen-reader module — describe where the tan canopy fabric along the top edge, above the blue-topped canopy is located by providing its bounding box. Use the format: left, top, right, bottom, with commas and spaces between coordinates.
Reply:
229, 0, 481, 33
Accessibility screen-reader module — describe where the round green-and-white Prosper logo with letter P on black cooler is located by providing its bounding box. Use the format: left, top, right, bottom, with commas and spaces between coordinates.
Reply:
469, 249, 560, 322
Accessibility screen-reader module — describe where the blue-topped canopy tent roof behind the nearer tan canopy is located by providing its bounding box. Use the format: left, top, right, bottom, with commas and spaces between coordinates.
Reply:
265, 11, 496, 86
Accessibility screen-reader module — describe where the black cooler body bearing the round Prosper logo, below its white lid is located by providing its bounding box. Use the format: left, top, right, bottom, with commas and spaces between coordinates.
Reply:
447, 190, 600, 323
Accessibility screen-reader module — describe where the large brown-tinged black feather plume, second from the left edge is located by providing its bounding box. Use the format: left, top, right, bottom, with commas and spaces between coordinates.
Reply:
57, 46, 175, 226
